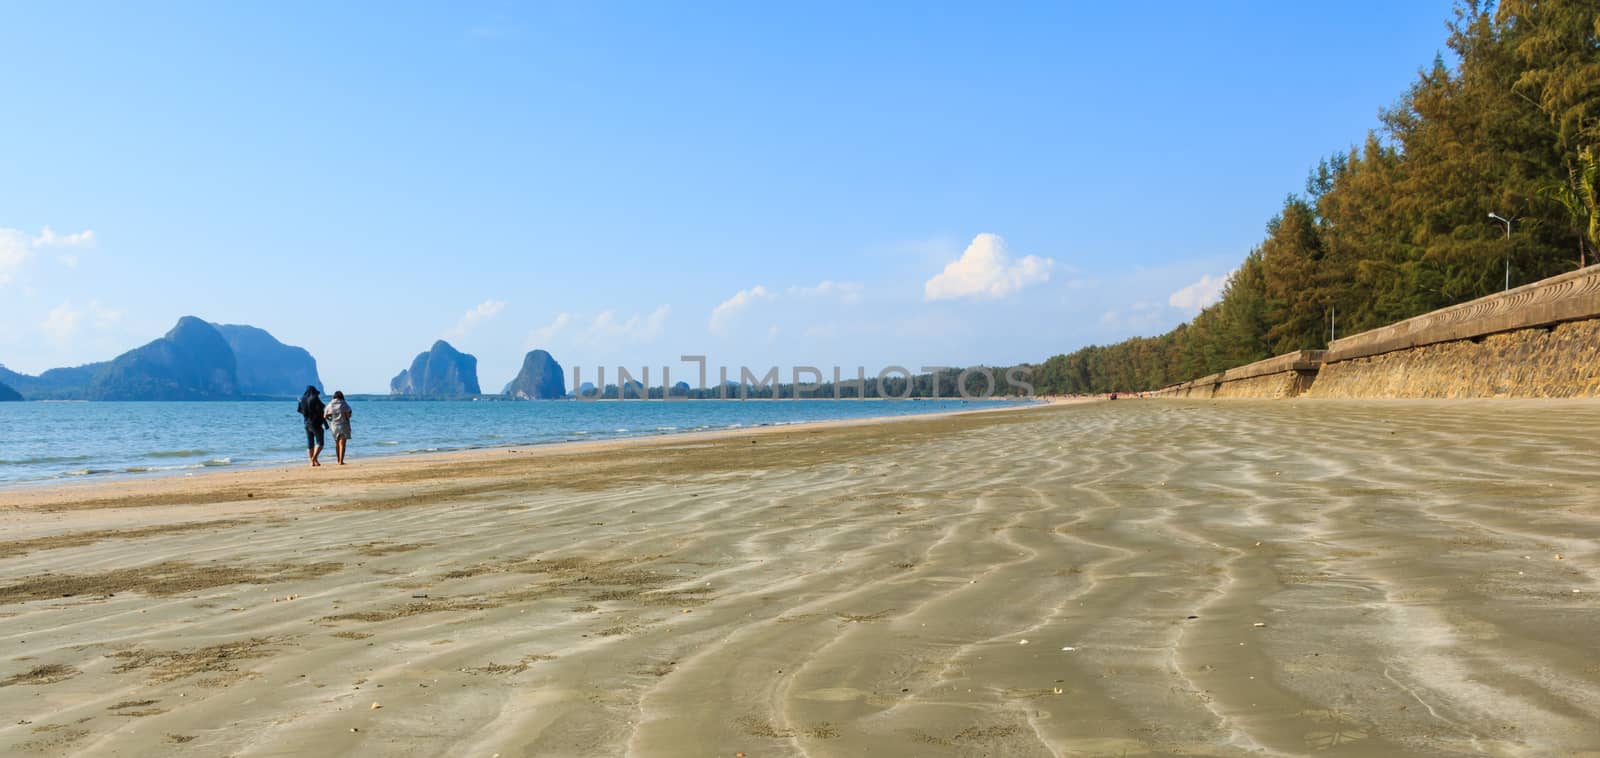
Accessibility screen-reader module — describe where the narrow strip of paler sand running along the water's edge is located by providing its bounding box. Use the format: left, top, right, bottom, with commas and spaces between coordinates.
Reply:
0, 397, 1099, 512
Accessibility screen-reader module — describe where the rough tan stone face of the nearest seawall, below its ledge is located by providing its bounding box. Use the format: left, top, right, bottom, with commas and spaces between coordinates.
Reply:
1309, 320, 1600, 398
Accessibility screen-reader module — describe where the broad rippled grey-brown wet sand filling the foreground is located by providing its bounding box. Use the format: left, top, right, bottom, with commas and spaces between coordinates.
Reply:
0, 400, 1600, 758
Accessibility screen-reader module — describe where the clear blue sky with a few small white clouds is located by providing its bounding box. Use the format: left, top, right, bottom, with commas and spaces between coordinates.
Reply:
0, 0, 1450, 392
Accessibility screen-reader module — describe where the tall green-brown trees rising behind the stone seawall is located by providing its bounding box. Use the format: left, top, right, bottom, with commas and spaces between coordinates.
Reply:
1034, 0, 1600, 393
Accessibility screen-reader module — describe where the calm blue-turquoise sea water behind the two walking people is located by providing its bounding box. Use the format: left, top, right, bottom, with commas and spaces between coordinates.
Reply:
0, 400, 1024, 485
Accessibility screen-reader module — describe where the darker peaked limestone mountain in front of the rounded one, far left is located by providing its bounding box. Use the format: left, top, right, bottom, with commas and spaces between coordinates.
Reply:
85, 317, 238, 400
